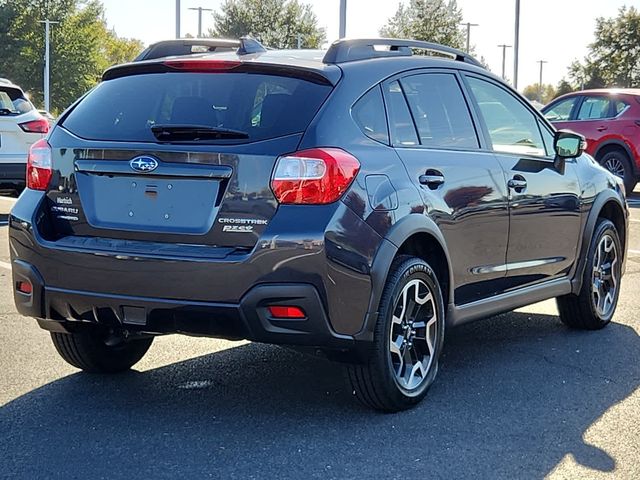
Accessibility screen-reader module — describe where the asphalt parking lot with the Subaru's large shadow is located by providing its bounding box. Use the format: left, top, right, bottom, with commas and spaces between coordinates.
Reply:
0, 194, 640, 479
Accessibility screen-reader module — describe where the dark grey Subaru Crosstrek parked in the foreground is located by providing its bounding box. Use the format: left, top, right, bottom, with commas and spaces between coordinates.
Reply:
9, 39, 628, 411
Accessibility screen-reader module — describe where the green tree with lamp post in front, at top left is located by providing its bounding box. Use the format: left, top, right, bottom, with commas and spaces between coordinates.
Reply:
0, 0, 142, 112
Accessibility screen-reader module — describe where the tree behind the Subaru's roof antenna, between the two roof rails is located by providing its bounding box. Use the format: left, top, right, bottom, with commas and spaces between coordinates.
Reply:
209, 0, 326, 48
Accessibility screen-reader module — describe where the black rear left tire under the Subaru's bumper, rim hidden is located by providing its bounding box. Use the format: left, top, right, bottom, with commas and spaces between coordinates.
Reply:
51, 331, 153, 373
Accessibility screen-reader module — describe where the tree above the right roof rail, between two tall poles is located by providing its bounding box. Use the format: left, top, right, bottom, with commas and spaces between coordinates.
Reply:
380, 0, 466, 49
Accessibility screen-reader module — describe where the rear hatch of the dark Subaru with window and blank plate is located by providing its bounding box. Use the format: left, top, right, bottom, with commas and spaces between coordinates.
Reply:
47, 59, 332, 253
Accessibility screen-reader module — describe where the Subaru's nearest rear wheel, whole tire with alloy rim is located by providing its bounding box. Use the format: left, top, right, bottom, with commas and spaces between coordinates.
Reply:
347, 256, 445, 412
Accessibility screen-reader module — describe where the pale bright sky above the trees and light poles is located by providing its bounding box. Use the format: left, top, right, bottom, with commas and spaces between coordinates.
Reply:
103, 0, 640, 88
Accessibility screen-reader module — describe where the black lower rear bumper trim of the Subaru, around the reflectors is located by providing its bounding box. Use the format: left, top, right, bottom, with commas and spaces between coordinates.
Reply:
12, 260, 354, 349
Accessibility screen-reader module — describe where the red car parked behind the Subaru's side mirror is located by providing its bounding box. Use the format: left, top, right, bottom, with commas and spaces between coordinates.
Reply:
542, 89, 640, 192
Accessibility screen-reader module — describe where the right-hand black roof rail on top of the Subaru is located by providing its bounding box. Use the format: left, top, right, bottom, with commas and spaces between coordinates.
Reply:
323, 38, 484, 68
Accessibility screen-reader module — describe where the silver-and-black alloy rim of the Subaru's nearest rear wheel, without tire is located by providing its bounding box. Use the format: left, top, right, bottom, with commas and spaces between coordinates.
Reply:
389, 279, 438, 390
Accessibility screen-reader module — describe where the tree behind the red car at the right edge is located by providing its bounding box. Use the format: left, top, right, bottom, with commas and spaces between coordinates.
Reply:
569, 7, 640, 88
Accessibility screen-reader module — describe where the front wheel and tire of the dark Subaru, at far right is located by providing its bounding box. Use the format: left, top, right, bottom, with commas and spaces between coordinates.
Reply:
556, 218, 622, 330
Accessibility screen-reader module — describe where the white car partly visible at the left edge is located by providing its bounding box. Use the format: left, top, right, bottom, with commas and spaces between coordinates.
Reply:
0, 79, 49, 193
